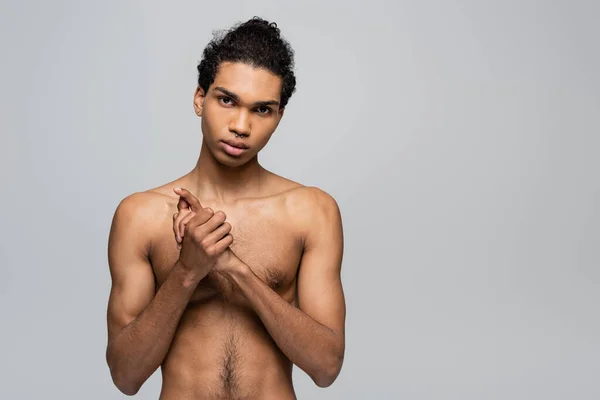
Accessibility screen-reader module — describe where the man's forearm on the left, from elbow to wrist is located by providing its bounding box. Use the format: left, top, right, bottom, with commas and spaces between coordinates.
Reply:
106, 263, 199, 394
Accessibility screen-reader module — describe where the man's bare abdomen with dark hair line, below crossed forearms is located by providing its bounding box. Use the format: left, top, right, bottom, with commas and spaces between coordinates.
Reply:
160, 298, 296, 400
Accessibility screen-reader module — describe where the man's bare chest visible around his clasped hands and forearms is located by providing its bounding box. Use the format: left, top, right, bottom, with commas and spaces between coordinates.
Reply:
150, 204, 302, 305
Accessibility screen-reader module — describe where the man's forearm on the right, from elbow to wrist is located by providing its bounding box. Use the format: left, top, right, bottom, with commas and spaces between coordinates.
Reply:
228, 262, 344, 387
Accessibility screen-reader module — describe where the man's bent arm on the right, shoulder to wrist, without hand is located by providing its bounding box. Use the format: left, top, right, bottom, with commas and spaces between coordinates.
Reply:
227, 188, 346, 387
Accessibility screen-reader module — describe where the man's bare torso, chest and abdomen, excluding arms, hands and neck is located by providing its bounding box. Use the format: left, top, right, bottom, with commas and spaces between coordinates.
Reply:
142, 177, 306, 400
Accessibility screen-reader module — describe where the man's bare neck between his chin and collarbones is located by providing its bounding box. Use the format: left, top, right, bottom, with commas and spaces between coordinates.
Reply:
188, 140, 267, 203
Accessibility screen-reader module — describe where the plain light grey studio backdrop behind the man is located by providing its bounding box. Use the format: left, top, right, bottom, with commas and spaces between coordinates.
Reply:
0, 0, 600, 399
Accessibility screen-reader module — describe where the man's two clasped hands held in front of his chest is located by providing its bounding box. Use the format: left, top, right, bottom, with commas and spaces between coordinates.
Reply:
173, 188, 233, 278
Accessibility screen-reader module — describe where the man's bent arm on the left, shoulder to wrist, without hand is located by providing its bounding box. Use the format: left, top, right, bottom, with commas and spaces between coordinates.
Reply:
106, 193, 198, 395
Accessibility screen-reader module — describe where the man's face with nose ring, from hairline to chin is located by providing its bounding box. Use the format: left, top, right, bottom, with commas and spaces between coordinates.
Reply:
194, 62, 283, 167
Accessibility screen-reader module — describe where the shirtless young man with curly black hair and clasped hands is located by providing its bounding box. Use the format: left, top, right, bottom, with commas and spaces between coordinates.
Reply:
106, 18, 346, 400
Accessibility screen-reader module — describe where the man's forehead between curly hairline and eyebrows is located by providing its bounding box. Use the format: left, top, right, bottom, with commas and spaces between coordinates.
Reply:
211, 62, 283, 103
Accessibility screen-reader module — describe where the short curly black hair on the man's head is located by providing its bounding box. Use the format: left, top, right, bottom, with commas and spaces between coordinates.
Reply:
198, 17, 296, 107
